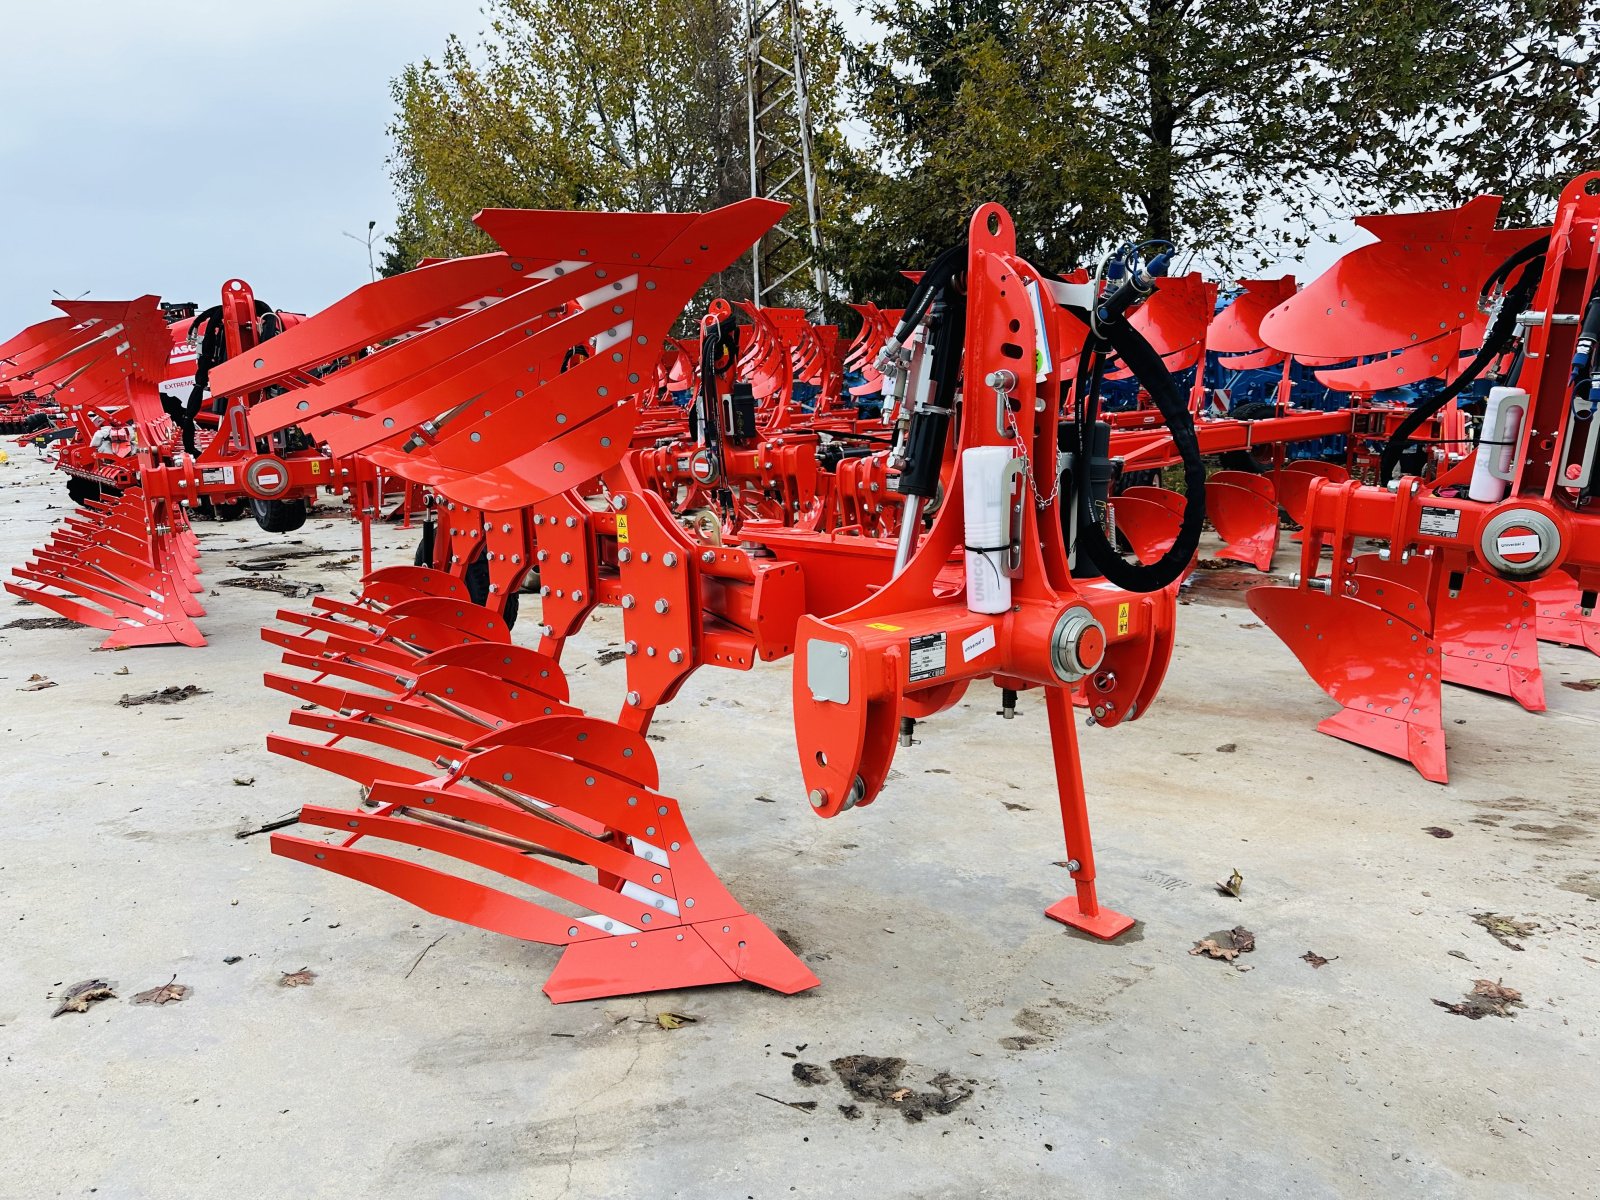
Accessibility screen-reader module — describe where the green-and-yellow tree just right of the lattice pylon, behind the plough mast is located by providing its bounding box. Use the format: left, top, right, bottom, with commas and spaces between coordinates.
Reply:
829, 0, 1126, 302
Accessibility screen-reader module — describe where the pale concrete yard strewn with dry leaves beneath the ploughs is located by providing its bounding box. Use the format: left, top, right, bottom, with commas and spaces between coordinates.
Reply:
0, 451, 1600, 1200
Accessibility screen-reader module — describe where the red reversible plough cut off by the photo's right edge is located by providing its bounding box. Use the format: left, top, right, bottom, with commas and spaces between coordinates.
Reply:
1250, 174, 1600, 782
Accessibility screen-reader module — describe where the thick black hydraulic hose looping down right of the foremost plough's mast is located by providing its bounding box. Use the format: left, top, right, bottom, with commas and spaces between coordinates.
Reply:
1072, 309, 1205, 592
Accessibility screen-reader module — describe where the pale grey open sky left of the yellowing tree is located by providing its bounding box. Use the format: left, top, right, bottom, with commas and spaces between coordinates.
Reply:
0, 0, 480, 341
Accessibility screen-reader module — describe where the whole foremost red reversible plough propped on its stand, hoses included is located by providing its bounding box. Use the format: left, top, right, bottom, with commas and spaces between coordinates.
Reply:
196, 202, 1203, 1000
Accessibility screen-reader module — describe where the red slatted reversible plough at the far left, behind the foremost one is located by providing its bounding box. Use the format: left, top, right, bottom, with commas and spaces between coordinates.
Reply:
0, 280, 393, 646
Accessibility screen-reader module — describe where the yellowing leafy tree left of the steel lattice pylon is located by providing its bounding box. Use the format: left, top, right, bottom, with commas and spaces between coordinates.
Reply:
386, 0, 749, 286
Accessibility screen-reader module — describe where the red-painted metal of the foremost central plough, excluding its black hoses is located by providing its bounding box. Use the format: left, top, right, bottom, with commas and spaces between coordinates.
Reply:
249, 206, 1203, 1000
